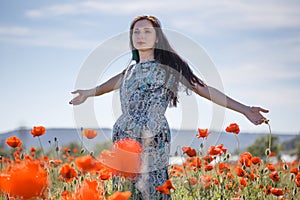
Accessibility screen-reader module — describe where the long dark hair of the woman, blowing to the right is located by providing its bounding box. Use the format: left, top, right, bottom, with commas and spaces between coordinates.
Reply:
130, 15, 205, 106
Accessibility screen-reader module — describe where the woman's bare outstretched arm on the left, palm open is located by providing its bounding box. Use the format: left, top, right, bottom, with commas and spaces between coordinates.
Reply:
69, 73, 123, 105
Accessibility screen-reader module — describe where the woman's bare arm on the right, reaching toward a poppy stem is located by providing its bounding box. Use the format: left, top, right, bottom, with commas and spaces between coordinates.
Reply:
194, 84, 269, 125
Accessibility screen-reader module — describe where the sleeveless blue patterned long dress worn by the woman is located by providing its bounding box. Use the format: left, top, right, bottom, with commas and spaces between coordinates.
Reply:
113, 61, 175, 200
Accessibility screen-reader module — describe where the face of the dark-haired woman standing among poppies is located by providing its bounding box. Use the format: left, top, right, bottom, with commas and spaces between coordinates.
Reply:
132, 19, 157, 51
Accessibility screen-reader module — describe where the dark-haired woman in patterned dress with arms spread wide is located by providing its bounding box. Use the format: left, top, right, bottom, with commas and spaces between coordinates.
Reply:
70, 16, 268, 199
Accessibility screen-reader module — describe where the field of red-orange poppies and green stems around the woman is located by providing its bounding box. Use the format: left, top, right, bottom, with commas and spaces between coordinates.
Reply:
0, 122, 300, 200
